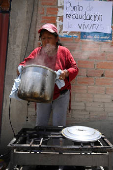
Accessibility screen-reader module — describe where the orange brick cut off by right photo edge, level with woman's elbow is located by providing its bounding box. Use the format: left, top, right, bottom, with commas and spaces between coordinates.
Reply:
96, 61, 113, 69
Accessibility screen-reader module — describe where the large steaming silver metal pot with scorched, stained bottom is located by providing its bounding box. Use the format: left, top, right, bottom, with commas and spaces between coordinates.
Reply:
18, 65, 56, 103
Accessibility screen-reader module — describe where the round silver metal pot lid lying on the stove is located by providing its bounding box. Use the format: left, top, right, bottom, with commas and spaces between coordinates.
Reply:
62, 126, 101, 142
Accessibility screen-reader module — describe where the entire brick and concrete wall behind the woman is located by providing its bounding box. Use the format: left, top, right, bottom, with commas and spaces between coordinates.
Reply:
1, 0, 113, 152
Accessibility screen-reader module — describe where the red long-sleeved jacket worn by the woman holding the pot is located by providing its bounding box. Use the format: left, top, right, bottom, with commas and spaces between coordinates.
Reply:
20, 46, 78, 100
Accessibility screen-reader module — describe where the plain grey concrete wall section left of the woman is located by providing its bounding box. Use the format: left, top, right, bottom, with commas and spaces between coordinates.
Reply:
0, 0, 38, 152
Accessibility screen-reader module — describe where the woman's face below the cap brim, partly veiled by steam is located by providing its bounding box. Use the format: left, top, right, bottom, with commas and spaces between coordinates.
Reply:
41, 30, 58, 47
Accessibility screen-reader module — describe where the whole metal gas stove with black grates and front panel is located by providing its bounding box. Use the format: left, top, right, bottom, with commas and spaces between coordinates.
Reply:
8, 127, 113, 170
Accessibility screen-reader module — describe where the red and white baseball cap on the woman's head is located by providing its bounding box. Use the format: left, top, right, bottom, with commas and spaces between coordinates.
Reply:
38, 23, 58, 34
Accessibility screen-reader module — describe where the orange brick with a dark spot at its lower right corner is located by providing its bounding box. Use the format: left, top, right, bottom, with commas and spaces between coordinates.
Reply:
87, 69, 104, 77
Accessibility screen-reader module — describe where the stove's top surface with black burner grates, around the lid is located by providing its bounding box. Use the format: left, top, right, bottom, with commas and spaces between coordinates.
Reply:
8, 126, 112, 153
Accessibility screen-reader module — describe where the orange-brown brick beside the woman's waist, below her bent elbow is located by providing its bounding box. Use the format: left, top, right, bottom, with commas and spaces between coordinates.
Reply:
71, 85, 87, 93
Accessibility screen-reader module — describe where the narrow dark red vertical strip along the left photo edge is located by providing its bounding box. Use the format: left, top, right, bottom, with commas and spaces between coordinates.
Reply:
0, 13, 9, 129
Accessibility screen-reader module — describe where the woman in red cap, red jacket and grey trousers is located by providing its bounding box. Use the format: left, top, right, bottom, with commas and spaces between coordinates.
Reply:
20, 23, 79, 126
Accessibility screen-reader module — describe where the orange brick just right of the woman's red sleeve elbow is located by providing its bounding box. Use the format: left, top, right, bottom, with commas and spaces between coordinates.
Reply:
78, 60, 94, 68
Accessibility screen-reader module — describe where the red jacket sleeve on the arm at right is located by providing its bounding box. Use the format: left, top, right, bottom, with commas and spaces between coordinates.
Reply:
66, 49, 79, 82
